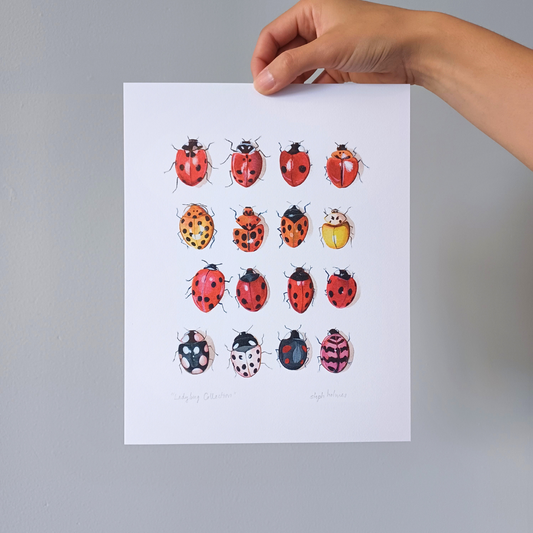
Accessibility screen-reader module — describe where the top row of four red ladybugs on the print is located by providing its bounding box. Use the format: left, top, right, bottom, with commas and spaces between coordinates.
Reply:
167, 139, 364, 190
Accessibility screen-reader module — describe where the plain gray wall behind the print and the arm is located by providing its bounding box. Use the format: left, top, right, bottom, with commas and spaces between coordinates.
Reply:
0, 0, 533, 533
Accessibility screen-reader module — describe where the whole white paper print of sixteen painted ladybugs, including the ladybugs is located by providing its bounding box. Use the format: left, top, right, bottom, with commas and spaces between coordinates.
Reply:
125, 84, 410, 443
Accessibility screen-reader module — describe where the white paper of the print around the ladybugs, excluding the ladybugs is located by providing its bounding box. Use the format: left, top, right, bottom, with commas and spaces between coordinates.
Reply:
125, 84, 410, 443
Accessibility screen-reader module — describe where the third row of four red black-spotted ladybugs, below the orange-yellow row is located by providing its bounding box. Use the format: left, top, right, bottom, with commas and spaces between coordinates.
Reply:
187, 264, 357, 313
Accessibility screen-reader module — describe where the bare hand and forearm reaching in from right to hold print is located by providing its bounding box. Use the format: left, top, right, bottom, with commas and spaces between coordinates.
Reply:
251, 0, 533, 170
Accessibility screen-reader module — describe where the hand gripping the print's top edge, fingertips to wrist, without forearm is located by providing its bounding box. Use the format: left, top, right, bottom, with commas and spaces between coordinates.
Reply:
251, 0, 431, 94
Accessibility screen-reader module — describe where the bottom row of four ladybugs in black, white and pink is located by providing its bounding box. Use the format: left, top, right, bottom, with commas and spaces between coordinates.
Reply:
174, 329, 351, 378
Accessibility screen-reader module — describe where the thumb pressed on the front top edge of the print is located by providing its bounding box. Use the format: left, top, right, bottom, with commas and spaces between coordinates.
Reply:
254, 37, 330, 94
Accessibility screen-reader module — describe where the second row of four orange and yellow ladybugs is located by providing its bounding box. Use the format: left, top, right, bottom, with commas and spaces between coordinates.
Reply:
181, 204, 352, 252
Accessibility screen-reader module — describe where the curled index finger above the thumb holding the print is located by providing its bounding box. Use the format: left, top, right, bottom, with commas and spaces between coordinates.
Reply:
250, 2, 316, 78
